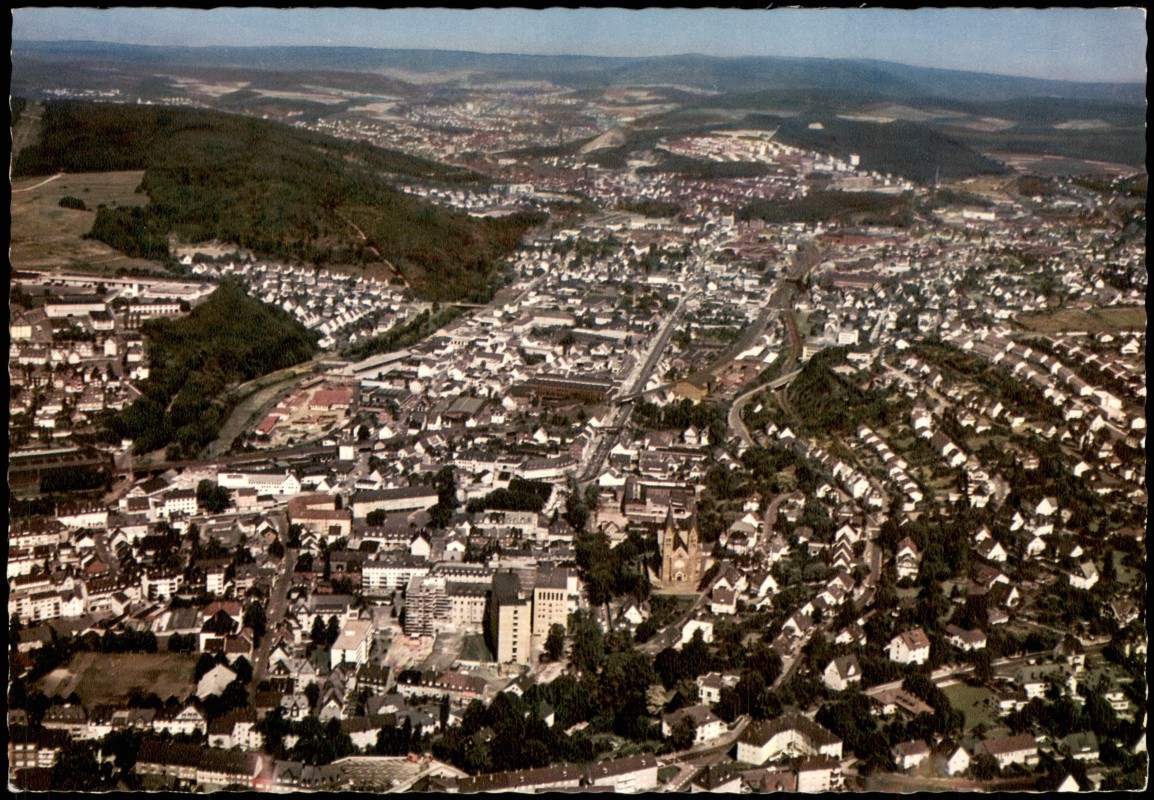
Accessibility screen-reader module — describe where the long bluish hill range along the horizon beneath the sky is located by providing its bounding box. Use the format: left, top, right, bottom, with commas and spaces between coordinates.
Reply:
13, 42, 1146, 104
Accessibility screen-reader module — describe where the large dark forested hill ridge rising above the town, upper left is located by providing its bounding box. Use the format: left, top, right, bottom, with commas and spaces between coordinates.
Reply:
13, 102, 544, 302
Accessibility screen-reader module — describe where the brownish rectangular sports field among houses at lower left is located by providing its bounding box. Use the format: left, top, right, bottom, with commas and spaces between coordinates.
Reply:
44, 652, 196, 706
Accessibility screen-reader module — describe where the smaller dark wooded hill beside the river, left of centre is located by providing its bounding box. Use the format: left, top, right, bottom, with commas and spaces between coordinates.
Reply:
108, 282, 316, 458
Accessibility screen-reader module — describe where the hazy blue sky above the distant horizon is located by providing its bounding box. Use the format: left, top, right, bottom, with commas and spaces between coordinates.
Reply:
13, 7, 1146, 83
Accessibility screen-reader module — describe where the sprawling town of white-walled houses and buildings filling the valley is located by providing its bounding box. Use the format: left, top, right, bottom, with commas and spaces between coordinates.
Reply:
7, 70, 1147, 792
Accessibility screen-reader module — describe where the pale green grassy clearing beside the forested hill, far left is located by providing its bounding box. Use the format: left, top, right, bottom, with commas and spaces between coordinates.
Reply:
12, 170, 163, 275
